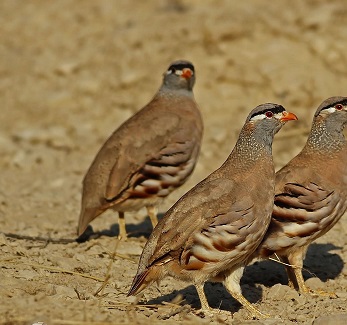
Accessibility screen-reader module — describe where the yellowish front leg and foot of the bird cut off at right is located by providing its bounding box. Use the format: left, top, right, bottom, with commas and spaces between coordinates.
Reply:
287, 249, 336, 298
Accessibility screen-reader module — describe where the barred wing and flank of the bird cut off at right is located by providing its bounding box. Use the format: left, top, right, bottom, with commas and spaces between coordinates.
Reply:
265, 183, 341, 244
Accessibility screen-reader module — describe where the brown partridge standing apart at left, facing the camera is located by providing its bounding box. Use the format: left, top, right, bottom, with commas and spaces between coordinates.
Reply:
77, 60, 203, 240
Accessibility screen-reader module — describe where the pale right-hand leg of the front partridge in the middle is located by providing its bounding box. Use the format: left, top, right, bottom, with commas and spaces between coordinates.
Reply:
224, 267, 270, 319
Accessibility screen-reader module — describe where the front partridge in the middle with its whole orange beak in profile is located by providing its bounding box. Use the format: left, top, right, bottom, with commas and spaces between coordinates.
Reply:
128, 103, 297, 318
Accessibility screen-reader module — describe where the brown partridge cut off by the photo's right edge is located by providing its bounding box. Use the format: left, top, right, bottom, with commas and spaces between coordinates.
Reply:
257, 97, 347, 293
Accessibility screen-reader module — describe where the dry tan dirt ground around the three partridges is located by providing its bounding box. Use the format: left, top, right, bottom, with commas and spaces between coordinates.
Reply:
0, 0, 347, 325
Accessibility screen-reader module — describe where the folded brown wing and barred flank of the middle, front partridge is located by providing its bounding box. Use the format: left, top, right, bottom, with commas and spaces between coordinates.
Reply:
139, 179, 255, 272
